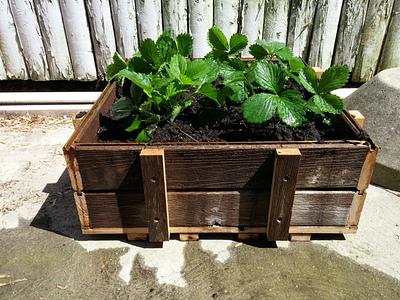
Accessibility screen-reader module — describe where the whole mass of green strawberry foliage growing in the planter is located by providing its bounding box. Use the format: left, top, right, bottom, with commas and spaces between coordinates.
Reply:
107, 27, 349, 142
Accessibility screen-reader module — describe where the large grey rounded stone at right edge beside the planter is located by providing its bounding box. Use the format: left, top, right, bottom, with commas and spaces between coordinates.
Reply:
345, 68, 400, 191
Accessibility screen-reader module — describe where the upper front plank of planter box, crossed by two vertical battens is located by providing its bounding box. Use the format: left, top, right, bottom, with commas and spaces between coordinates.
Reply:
76, 144, 368, 190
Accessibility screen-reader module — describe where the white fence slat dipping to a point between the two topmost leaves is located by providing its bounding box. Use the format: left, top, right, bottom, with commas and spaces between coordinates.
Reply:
214, 0, 240, 39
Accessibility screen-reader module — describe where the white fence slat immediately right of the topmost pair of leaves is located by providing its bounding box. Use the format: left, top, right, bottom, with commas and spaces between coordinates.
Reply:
242, 0, 264, 56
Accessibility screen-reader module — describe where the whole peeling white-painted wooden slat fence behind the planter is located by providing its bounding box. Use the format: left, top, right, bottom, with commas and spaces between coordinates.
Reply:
0, 0, 400, 82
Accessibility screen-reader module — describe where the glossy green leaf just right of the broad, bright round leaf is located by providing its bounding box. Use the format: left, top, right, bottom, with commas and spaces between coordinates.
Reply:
278, 90, 306, 127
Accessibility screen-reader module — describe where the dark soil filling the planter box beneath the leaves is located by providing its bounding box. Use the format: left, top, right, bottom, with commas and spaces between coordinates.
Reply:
98, 81, 357, 143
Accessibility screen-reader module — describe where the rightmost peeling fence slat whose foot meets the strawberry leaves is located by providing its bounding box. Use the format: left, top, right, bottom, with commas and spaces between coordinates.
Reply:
333, 0, 368, 70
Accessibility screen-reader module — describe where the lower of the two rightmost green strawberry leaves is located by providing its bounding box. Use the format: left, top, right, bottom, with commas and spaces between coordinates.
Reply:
307, 94, 344, 114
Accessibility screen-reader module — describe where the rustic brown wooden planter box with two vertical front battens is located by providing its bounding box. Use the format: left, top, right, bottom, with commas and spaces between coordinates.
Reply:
64, 83, 378, 242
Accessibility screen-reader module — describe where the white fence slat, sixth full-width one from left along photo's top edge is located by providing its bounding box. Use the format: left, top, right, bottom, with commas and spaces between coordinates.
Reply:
136, 0, 162, 41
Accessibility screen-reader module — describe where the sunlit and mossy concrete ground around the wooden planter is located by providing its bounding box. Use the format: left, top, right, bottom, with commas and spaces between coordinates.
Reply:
0, 117, 400, 299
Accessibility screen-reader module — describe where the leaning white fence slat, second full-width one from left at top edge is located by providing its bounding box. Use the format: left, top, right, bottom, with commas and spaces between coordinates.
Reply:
34, 1, 74, 80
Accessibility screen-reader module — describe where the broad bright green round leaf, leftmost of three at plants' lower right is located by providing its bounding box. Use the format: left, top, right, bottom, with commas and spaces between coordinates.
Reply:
242, 93, 279, 123
